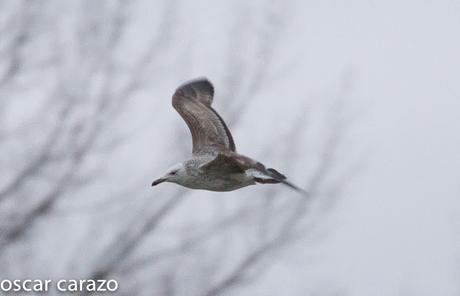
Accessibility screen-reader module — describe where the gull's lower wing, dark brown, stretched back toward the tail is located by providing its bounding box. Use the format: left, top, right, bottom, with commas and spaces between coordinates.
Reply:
200, 150, 305, 193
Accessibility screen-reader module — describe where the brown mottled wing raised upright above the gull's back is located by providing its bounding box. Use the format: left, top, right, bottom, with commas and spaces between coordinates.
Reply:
172, 79, 236, 154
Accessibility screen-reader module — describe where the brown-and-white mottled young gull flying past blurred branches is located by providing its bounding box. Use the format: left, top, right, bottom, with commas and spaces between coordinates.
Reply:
152, 78, 303, 191
